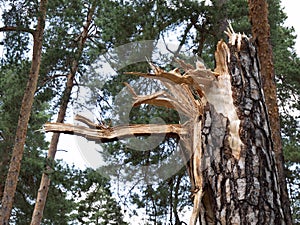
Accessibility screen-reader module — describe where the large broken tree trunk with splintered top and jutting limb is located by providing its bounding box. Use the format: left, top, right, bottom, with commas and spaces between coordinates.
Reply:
45, 30, 287, 225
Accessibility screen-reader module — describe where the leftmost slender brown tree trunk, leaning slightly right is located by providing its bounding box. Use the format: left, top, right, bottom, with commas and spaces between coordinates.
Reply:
0, 0, 47, 225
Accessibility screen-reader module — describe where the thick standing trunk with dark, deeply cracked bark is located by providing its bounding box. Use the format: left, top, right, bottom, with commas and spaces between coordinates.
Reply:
190, 37, 287, 225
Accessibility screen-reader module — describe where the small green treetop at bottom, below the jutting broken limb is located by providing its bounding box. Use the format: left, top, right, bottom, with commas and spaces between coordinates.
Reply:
70, 169, 127, 225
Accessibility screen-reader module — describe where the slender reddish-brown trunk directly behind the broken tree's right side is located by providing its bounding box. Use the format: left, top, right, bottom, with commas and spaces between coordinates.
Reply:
248, 0, 292, 225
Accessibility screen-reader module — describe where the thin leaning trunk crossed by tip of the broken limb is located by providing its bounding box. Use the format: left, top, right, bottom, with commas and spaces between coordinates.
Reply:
31, 4, 96, 225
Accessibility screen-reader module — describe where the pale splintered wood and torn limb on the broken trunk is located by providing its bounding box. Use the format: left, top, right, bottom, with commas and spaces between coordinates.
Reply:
45, 27, 246, 225
